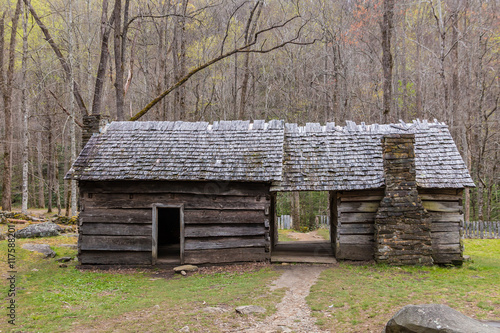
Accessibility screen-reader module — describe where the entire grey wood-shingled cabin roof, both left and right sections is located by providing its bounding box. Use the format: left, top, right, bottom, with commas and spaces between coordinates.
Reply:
66, 120, 474, 191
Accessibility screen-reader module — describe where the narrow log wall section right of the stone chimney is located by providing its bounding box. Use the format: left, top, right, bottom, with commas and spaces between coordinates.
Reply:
418, 189, 463, 264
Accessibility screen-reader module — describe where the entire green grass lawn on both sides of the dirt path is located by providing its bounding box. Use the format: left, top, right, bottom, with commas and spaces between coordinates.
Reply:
0, 230, 500, 332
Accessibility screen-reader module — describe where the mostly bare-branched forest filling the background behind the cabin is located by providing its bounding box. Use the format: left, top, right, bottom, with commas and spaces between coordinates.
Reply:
0, 0, 500, 220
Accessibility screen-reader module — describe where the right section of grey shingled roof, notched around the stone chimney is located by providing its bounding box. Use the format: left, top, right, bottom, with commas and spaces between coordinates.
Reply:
273, 121, 474, 191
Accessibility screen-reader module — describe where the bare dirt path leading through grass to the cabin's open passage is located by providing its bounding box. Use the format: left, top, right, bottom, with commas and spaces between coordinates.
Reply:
242, 265, 326, 333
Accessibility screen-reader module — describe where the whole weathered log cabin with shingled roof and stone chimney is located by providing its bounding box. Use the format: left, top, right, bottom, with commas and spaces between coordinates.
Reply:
66, 116, 474, 265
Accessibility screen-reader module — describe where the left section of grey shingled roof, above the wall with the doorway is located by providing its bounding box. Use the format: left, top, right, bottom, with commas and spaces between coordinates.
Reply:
67, 120, 284, 182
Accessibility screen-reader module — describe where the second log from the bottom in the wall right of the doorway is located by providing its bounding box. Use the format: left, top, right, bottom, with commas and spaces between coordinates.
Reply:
184, 236, 267, 251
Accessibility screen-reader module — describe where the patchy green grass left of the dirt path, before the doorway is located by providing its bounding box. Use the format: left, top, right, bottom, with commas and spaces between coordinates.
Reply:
0, 237, 284, 332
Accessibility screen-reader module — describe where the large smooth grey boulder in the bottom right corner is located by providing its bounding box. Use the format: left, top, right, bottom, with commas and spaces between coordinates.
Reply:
385, 304, 500, 333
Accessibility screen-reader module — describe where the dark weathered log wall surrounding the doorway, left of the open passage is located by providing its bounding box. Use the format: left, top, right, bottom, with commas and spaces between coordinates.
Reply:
79, 182, 271, 264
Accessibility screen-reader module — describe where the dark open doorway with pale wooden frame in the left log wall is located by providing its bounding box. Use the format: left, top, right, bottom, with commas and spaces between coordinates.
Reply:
153, 205, 184, 265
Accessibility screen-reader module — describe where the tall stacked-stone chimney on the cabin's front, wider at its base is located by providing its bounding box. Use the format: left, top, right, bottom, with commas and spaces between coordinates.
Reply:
375, 134, 433, 265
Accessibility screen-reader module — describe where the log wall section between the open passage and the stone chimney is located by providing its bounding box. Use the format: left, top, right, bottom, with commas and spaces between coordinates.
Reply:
332, 190, 384, 260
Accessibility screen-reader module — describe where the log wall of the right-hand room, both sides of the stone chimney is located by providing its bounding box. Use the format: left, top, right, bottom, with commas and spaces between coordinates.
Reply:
331, 188, 463, 264
